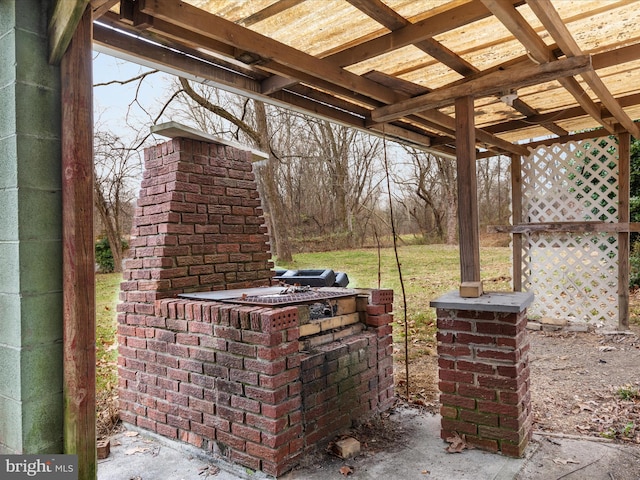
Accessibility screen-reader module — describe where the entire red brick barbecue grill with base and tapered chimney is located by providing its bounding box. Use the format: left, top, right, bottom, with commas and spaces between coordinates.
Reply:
118, 134, 393, 476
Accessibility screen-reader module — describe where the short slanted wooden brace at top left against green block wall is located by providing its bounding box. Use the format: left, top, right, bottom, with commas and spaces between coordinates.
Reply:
49, 0, 89, 65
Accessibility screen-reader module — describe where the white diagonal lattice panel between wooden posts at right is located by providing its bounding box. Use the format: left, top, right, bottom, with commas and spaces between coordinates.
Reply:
522, 138, 618, 325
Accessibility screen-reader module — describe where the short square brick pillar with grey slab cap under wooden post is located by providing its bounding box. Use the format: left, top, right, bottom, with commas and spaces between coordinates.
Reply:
431, 292, 533, 457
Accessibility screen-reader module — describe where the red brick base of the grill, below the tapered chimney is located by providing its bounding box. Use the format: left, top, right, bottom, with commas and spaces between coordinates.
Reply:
118, 292, 393, 476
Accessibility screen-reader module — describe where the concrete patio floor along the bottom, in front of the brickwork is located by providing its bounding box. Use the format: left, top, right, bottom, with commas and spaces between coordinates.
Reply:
98, 407, 640, 480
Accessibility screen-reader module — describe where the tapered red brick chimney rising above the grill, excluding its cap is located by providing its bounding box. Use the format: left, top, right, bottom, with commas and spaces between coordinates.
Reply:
121, 138, 274, 313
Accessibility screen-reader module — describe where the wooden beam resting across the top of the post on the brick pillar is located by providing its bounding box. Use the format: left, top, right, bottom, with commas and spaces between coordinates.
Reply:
371, 55, 591, 122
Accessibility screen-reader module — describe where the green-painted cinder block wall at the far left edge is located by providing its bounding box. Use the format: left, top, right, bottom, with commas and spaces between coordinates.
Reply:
0, 0, 63, 454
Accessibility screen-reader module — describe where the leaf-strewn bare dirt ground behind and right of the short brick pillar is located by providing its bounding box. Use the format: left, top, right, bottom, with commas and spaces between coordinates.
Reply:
395, 326, 640, 444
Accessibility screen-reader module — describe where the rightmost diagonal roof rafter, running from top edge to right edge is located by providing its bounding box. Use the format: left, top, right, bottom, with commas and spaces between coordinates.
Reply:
527, 0, 640, 138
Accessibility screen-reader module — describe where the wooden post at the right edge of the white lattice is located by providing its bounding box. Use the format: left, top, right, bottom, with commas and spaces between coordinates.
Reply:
618, 132, 631, 330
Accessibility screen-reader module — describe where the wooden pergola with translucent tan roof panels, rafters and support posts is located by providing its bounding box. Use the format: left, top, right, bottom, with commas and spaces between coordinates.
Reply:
49, 0, 640, 478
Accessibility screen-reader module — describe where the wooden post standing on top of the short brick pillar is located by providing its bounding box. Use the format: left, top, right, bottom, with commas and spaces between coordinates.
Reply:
456, 96, 480, 283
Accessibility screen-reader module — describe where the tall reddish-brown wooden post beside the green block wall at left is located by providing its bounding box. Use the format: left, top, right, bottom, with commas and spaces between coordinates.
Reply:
60, 8, 97, 480
